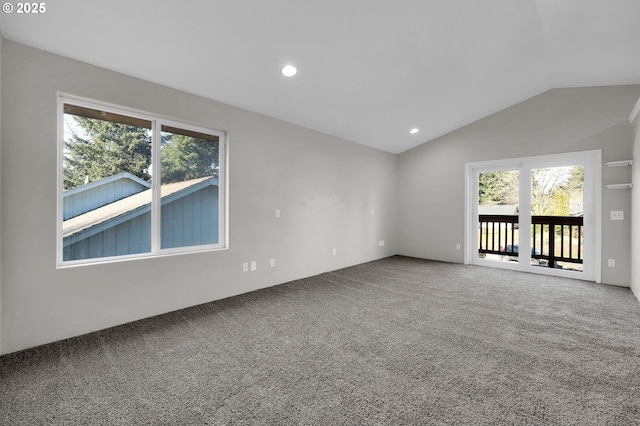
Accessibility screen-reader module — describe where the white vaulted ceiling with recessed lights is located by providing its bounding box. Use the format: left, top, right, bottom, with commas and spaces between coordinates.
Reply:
0, 0, 640, 153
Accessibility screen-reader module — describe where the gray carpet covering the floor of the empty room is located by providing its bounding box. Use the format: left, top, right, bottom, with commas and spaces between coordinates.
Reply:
0, 256, 640, 425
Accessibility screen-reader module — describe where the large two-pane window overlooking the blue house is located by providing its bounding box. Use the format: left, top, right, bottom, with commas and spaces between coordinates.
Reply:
58, 98, 225, 265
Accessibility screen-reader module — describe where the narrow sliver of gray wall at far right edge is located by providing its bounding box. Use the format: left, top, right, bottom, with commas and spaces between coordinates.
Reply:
631, 103, 640, 300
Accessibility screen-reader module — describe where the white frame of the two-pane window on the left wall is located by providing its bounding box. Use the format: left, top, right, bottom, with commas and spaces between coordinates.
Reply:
56, 93, 229, 268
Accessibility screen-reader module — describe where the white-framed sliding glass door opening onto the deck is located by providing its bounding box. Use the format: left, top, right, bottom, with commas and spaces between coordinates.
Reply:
466, 151, 601, 281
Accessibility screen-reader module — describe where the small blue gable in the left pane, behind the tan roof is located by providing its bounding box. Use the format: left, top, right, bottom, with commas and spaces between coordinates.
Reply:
63, 173, 151, 220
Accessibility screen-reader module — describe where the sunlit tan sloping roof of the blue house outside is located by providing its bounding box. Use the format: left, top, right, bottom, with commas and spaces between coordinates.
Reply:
62, 176, 218, 246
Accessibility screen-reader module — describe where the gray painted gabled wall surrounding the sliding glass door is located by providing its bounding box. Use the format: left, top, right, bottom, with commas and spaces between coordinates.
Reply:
398, 85, 640, 286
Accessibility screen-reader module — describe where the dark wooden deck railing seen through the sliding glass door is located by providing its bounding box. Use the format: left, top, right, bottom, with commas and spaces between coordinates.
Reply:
478, 215, 584, 268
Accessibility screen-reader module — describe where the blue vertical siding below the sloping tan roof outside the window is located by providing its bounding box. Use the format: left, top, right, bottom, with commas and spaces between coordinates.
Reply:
63, 179, 218, 261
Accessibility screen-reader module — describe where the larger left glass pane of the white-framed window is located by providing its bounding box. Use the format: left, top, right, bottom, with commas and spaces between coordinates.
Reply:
62, 105, 151, 261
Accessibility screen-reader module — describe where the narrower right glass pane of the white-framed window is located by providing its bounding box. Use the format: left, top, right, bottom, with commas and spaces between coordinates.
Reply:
160, 126, 220, 249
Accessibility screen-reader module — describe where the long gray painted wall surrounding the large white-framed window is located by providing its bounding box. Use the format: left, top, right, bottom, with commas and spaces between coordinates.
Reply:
1, 41, 398, 353
